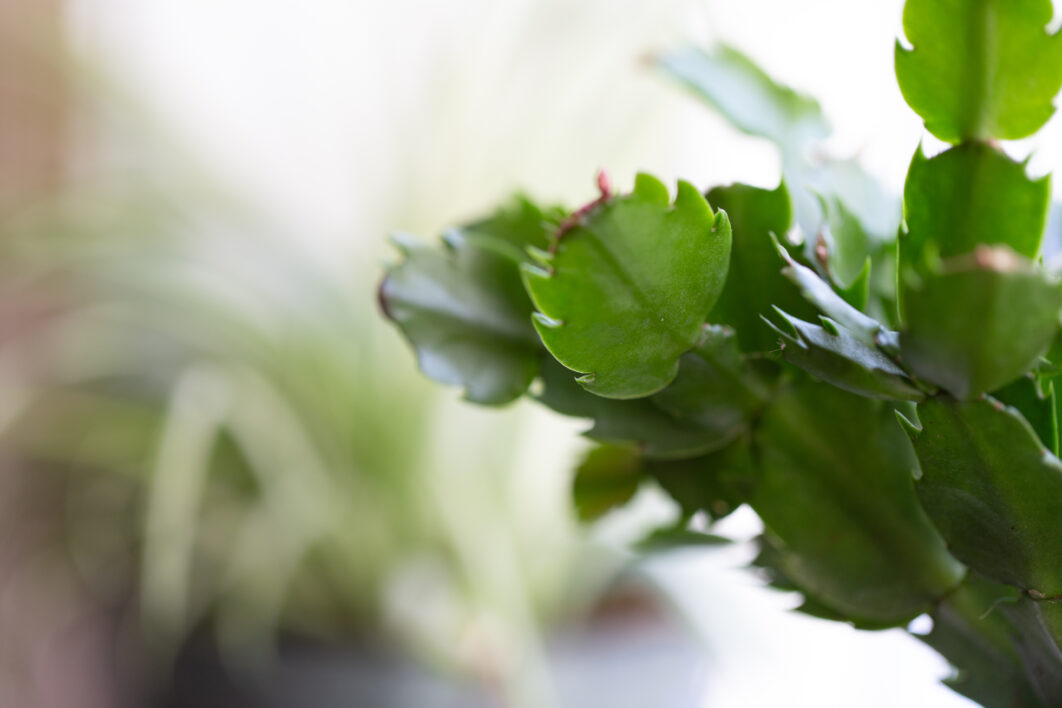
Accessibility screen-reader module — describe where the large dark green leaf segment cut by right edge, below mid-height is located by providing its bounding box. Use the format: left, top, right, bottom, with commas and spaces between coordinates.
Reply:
902, 397, 1062, 597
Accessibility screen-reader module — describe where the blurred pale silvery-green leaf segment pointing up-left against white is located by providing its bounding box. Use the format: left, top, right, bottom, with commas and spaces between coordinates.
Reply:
660, 46, 829, 152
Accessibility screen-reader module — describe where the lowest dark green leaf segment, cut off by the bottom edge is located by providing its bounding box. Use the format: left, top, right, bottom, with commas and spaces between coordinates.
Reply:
920, 574, 1058, 708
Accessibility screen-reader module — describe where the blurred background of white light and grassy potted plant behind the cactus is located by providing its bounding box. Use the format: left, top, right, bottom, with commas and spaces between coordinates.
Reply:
8, 0, 1062, 708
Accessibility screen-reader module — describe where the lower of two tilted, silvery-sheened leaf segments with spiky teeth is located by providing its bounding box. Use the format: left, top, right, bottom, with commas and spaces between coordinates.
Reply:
768, 310, 924, 400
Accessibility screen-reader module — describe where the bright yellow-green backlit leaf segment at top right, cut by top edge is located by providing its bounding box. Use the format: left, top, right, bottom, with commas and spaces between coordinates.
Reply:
895, 0, 1062, 143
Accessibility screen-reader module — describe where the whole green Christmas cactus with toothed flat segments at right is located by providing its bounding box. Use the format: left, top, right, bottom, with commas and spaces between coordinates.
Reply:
380, 0, 1062, 706
